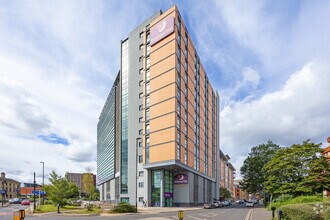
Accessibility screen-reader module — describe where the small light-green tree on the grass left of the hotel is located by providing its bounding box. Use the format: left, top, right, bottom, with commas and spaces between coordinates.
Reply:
44, 170, 79, 207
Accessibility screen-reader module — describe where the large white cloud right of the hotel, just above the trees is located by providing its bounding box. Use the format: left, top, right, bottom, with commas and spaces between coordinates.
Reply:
220, 60, 330, 177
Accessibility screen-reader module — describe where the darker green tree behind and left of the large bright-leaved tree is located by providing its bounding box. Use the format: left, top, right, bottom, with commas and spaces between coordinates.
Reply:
240, 141, 280, 194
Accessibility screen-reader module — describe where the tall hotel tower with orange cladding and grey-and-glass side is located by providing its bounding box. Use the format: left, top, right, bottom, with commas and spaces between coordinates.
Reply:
97, 6, 219, 206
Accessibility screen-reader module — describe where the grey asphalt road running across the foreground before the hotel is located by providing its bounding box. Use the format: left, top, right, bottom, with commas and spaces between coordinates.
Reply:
0, 205, 251, 220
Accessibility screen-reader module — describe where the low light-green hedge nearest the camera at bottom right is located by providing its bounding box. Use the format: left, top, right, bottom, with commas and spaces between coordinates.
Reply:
282, 205, 321, 220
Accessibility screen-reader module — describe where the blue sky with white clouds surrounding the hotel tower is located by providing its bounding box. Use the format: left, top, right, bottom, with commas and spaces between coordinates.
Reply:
0, 0, 330, 183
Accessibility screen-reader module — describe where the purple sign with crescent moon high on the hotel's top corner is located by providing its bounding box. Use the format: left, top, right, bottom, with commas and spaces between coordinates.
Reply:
150, 16, 174, 46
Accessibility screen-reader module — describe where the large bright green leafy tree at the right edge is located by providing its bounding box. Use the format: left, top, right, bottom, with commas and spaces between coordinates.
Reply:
263, 140, 330, 196
